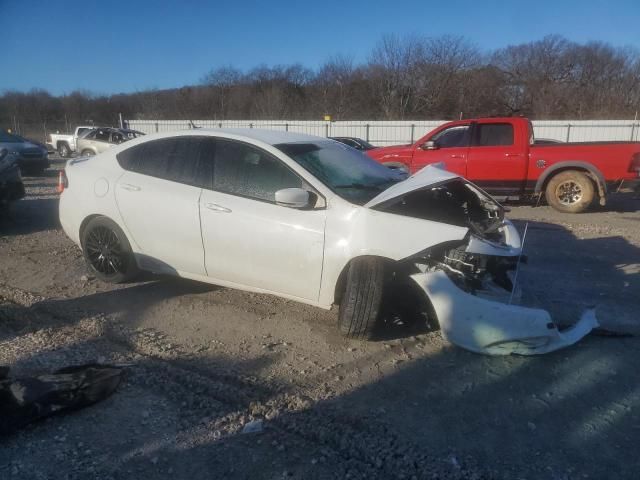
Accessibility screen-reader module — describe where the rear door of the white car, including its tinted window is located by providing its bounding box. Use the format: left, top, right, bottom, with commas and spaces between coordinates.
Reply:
115, 136, 210, 276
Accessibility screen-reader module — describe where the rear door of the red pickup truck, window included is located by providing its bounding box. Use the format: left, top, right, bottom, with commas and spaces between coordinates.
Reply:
467, 120, 529, 195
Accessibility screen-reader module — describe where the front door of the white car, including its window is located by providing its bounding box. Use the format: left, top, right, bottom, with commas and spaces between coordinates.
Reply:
200, 138, 326, 301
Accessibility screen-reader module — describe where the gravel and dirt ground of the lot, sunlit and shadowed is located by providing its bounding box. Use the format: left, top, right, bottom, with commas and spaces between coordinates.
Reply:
0, 157, 640, 480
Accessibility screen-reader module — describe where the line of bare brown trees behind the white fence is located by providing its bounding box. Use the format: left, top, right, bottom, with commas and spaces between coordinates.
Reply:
0, 35, 640, 140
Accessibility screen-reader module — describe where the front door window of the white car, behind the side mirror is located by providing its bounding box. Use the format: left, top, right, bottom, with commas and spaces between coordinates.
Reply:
208, 138, 303, 202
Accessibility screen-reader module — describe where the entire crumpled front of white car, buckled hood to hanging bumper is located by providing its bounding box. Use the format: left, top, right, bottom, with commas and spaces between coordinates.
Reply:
366, 166, 598, 355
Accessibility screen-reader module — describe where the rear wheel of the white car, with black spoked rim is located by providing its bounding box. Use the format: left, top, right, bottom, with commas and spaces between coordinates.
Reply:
80, 217, 139, 283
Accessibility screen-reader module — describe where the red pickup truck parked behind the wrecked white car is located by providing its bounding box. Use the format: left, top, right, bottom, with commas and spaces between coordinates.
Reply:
366, 117, 640, 213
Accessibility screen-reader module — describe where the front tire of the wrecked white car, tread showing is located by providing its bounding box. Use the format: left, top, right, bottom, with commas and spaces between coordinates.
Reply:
338, 257, 385, 339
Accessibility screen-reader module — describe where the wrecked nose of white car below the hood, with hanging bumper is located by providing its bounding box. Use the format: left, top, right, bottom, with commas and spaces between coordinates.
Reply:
411, 220, 598, 355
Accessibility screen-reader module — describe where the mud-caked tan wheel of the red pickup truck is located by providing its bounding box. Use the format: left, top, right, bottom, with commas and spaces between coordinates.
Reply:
545, 170, 595, 213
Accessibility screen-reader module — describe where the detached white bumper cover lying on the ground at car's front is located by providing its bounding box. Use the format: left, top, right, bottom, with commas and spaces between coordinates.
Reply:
412, 270, 598, 355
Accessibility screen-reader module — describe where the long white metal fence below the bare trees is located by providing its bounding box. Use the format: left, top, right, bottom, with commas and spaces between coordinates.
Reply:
125, 120, 640, 146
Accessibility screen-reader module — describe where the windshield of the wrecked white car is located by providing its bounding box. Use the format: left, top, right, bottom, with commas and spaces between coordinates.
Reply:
274, 141, 406, 205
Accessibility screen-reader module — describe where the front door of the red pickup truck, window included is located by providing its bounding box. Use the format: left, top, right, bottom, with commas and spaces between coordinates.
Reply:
411, 123, 471, 176
